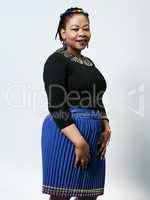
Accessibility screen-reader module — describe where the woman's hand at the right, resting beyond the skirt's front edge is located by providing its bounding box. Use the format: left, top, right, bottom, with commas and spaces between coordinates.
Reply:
98, 120, 111, 159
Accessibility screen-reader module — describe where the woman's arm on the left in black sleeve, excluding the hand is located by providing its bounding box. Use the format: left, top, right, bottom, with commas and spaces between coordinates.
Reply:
43, 54, 85, 146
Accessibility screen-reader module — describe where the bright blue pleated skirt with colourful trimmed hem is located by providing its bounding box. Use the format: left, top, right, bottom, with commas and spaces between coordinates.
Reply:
41, 108, 106, 198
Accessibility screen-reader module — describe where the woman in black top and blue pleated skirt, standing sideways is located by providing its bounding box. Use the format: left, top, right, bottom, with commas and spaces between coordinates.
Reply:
41, 7, 111, 200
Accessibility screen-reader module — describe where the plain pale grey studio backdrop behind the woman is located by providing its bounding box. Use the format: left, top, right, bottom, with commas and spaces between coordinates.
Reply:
0, 0, 150, 200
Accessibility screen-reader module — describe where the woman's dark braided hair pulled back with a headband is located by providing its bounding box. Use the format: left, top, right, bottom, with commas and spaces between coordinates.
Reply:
55, 7, 89, 41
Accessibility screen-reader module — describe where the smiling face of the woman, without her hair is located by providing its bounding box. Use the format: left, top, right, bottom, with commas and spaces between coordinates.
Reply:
61, 14, 91, 51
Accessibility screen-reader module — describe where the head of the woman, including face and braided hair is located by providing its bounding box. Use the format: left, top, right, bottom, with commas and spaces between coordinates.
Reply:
56, 9, 91, 56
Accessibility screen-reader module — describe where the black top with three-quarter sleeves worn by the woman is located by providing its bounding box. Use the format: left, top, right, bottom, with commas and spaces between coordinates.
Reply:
43, 48, 108, 129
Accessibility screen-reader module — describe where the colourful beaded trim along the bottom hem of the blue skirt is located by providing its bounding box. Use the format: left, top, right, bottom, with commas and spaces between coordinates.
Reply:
42, 185, 104, 197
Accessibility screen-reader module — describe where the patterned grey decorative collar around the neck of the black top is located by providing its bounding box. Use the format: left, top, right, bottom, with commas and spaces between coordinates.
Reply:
56, 47, 93, 66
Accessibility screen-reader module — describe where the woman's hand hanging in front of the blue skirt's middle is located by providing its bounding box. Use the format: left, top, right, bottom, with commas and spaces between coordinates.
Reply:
75, 141, 91, 169
